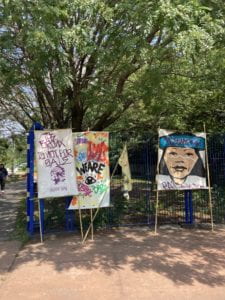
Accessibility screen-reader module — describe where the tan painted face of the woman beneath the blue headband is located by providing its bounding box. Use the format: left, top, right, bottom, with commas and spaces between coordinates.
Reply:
164, 147, 198, 184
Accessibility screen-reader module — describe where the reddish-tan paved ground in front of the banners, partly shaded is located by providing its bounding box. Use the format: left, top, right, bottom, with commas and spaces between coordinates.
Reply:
0, 226, 225, 300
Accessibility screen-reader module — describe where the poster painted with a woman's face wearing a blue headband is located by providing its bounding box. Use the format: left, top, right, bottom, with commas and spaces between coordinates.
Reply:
156, 129, 207, 190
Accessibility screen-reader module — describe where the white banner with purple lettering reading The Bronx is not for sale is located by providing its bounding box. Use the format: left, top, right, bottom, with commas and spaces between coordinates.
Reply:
35, 129, 78, 198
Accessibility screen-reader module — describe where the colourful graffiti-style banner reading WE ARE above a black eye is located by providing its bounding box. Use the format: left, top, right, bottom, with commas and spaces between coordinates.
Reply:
69, 131, 110, 209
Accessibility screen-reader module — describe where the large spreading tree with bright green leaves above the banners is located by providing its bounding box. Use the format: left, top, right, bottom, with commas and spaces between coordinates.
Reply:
0, 0, 223, 131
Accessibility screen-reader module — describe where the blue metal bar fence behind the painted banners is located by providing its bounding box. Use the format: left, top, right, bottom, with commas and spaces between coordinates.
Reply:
27, 129, 225, 233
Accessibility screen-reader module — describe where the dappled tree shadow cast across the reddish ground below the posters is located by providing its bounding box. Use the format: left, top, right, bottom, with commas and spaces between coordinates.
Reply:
5, 228, 225, 287
